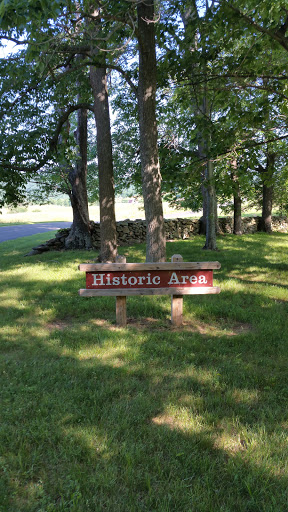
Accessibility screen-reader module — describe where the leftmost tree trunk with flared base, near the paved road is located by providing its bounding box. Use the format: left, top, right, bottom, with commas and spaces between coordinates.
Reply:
65, 109, 92, 249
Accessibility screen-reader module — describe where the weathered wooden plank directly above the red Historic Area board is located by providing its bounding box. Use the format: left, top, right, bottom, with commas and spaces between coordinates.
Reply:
78, 261, 221, 272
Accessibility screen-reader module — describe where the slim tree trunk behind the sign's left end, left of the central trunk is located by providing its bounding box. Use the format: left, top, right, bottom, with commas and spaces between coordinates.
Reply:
90, 66, 117, 262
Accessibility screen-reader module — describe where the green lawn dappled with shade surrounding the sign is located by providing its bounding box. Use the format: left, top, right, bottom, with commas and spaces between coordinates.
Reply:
0, 234, 288, 512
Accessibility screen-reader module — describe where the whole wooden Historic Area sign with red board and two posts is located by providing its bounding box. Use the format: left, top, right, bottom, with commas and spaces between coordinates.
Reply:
79, 254, 221, 326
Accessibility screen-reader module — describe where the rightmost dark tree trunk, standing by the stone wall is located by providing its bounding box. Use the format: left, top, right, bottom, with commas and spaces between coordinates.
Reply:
260, 153, 275, 233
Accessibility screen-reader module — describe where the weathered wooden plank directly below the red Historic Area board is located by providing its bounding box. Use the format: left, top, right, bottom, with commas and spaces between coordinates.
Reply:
78, 286, 220, 297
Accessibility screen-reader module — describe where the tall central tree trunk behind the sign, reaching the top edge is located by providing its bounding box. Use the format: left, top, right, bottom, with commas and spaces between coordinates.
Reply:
137, 0, 166, 262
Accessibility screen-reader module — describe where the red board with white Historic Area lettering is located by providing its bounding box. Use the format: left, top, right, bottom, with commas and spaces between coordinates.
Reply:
86, 269, 213, 291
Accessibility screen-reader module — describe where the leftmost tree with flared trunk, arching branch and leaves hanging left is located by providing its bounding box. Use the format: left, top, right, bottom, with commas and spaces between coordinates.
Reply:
0, 44, 97, 249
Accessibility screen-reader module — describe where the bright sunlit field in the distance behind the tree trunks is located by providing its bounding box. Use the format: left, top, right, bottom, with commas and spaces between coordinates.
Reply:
0, 202, 199, 224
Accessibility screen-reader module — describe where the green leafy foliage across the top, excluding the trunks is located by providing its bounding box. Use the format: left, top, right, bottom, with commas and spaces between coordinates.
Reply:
0, 0, 287, 218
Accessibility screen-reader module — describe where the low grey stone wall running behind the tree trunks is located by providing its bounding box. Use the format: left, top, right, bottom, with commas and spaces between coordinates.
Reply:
26, 217, 288, 256
